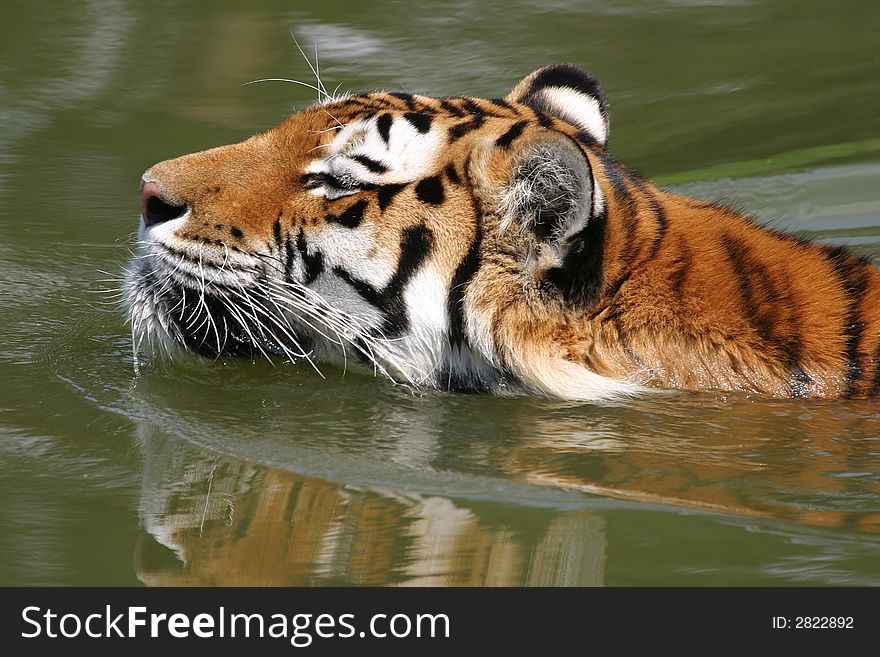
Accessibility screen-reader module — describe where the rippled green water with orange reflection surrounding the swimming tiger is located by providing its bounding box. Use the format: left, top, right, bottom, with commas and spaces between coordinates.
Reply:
0, 0, 880, 586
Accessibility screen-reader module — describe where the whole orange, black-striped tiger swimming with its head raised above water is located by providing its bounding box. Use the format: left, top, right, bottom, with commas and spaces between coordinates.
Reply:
125, 64, 880, 400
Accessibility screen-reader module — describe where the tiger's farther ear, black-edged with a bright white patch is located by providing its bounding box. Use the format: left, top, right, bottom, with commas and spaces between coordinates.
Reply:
506, 64, 610, 147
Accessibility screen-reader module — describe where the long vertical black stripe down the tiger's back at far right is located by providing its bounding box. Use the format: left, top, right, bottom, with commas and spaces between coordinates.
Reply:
826, 246, 869, 397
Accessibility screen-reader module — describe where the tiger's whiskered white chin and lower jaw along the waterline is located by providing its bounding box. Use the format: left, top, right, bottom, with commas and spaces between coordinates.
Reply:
124, 258, 488, 394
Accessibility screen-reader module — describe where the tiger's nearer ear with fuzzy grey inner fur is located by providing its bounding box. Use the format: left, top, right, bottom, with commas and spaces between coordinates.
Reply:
471, 130, 594, 276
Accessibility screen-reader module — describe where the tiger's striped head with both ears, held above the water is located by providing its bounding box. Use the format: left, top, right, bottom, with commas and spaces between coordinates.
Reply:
125, 65, 640, 398
